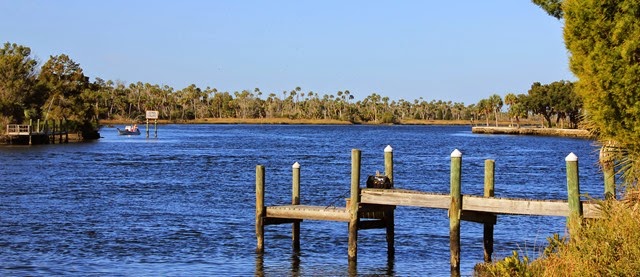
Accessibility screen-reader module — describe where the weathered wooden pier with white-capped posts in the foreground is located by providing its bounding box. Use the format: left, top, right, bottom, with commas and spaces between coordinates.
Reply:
256, 146, 600, 276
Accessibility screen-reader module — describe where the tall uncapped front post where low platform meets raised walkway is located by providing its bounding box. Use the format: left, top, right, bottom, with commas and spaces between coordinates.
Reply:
348, 149, 361, 263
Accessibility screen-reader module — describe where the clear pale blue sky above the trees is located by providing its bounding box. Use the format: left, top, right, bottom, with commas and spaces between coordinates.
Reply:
0, 0, 576, 105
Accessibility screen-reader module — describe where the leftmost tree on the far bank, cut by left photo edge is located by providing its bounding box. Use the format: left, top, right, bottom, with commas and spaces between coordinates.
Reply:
0, 42, 41, 125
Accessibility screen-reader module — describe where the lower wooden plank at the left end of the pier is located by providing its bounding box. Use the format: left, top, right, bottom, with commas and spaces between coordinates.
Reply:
266, 205, 349, 222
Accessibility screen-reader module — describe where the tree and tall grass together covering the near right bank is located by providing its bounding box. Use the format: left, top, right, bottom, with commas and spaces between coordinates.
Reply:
475, 0, 640, 276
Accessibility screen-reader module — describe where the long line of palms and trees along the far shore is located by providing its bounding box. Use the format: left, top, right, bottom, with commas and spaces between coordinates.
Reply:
0, 42, 582, 135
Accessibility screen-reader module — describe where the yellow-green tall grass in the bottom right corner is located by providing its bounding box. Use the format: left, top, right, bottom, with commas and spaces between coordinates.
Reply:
475, 188, 640, 276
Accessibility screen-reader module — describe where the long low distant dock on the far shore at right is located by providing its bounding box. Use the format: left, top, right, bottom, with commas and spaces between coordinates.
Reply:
471, 126, 592, 138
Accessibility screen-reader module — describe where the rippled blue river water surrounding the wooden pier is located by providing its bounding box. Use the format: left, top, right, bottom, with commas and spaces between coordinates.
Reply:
0, 125, 603, 276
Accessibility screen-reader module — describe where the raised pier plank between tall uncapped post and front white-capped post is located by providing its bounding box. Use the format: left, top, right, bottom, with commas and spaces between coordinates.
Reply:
360, 189, 451, 209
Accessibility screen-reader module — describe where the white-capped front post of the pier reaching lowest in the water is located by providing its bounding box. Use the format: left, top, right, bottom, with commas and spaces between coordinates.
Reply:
449, 149, 462, 276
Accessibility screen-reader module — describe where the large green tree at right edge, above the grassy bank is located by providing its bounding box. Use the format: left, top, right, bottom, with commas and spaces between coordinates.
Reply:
562, 0, 640, 184
